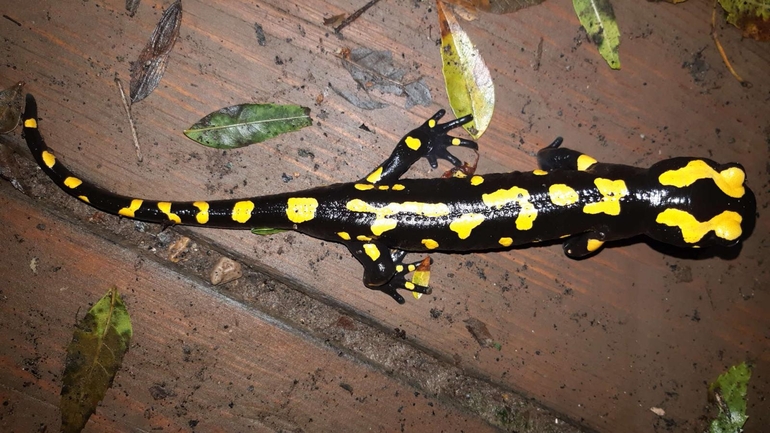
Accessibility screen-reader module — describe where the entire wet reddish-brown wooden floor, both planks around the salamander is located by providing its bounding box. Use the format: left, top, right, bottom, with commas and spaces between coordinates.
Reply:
0, 0, 770, 432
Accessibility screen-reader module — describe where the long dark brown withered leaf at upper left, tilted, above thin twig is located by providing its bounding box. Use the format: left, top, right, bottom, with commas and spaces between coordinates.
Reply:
131, 0, 182, 103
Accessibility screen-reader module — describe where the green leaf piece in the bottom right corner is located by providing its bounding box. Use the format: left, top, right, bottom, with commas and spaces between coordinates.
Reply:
709, 362, 751, 433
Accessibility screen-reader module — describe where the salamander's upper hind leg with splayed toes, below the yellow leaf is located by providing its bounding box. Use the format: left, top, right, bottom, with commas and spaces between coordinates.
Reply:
362, 110, 478, 184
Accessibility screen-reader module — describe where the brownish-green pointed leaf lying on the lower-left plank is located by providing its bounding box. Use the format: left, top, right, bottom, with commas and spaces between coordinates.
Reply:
60, 288, 133, 432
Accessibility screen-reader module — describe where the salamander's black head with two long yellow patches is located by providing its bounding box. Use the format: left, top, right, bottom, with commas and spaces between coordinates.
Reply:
647, 158, 757, 248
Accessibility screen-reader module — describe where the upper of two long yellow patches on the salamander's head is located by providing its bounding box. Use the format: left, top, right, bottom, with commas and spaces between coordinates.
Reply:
658, 159, 746, 198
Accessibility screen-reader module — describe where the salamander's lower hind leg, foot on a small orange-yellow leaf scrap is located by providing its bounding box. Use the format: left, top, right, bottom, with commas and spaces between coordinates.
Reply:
346, 241, 433, 304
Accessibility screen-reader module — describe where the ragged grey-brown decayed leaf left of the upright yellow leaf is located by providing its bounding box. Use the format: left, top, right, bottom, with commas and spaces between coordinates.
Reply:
337, 47, 432, 109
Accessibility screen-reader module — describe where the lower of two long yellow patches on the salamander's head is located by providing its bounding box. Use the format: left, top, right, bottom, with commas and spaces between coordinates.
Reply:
655, 209, 743, 244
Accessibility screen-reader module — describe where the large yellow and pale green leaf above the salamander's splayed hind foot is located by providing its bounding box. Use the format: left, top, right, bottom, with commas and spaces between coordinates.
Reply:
436, 0, 495, 139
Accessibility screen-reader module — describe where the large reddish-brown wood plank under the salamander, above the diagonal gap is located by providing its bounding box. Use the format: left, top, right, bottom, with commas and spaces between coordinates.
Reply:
0, 0, 770, 431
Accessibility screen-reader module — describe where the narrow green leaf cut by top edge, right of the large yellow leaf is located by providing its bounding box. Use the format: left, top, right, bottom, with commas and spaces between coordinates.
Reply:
572, 0, 620, 69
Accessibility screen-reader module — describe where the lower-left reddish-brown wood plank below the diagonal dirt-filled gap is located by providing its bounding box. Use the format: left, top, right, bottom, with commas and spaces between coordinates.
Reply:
0, 183, 504, 432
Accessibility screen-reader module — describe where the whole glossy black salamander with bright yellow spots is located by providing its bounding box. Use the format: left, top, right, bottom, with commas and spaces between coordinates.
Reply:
24, 95, 756, 303
